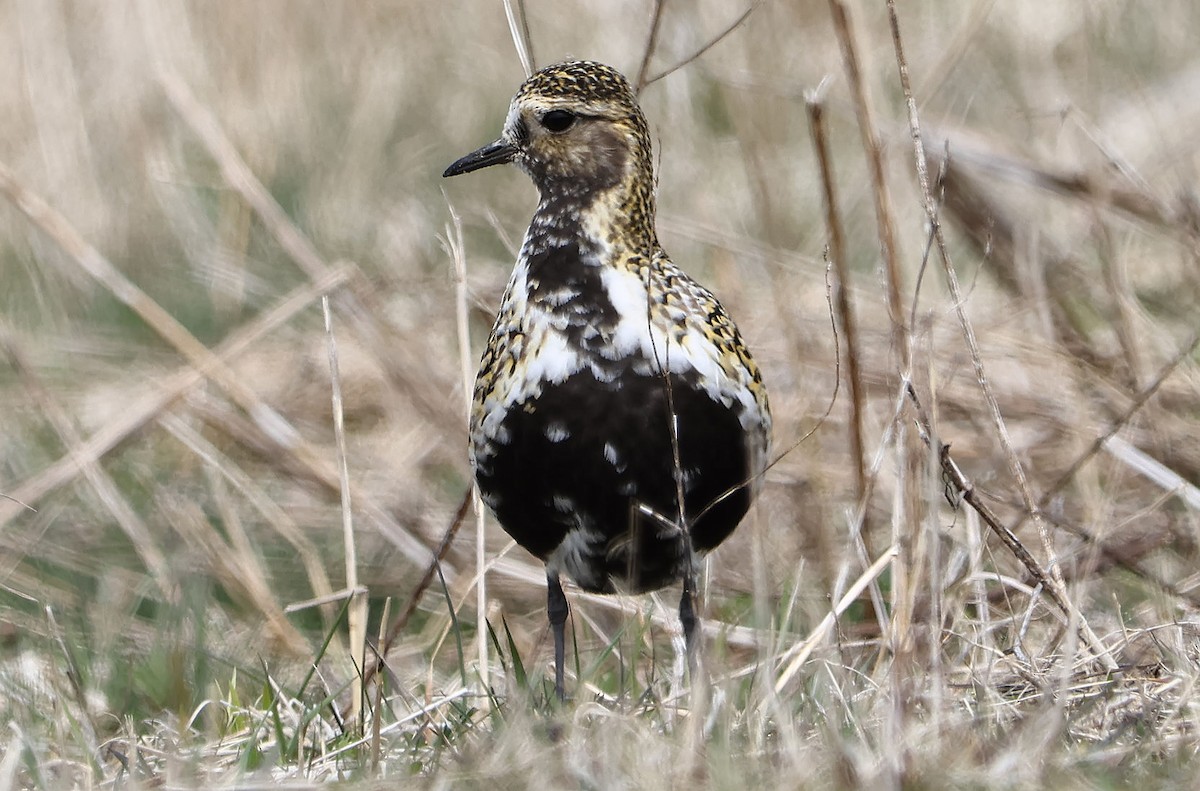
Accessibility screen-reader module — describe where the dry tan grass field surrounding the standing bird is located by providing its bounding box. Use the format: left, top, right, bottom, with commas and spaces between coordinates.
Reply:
0, 0, 1200, 790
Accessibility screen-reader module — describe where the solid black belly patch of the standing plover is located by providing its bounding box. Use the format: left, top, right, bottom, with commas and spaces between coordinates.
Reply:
475, 371, 750, 592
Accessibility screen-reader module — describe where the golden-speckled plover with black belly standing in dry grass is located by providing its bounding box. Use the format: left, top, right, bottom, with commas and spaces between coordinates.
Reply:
443, 60, 772, 701
